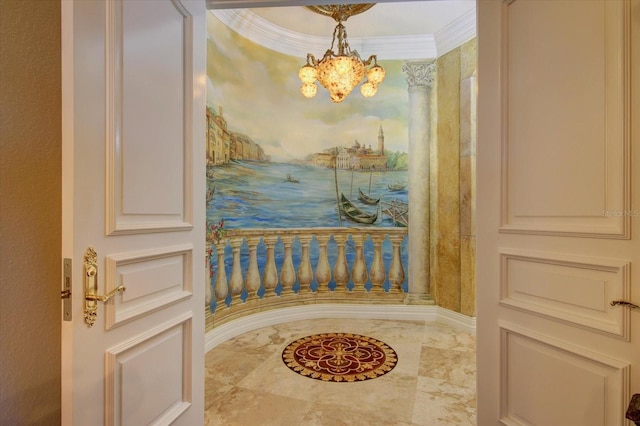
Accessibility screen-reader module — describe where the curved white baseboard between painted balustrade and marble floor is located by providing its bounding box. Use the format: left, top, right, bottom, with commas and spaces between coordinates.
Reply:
204, 304, 476, 353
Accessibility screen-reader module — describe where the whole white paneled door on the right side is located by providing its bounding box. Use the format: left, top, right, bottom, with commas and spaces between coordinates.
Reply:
477, 0, 640, 426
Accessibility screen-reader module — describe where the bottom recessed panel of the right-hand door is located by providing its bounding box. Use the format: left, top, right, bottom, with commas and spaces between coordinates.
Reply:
500, 323, 629, 426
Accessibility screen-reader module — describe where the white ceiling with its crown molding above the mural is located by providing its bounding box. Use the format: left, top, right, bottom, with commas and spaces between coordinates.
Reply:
207, 0, 476, 60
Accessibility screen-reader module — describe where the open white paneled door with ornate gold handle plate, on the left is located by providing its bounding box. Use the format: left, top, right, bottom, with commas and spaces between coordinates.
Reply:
62, 0, 206, 426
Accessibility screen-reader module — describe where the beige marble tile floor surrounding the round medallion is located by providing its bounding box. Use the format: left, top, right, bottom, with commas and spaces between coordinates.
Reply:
205, 319, 476, 426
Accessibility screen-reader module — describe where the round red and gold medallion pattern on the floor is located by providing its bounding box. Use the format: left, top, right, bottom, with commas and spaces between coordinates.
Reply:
282, 333, 398, 382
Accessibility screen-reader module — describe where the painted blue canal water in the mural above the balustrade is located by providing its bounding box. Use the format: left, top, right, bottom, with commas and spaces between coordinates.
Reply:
207, 161, 408, 229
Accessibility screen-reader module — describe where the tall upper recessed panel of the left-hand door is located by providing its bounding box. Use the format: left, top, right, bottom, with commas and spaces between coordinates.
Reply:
106, 1, 194, 234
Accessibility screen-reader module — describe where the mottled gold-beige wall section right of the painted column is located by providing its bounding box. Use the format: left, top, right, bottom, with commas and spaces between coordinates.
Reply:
430, 39, 476, 316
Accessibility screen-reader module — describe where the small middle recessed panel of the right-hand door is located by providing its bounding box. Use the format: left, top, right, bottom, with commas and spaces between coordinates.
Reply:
500, 248, 631, 340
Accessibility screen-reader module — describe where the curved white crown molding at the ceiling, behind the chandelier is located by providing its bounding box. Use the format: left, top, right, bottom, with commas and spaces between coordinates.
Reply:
210, 9, 476, 60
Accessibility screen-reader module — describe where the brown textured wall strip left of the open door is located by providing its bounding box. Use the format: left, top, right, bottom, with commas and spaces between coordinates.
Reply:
0, 0, 61, 425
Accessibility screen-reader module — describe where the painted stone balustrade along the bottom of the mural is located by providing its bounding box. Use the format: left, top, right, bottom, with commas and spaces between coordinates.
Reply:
205, 227, 407, 328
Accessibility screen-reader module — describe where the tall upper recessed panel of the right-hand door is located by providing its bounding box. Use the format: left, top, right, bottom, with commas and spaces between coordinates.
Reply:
501, 1, 631, 238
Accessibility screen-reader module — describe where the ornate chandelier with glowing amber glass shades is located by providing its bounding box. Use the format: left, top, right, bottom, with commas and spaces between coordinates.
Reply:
298, 3, 385, 103
